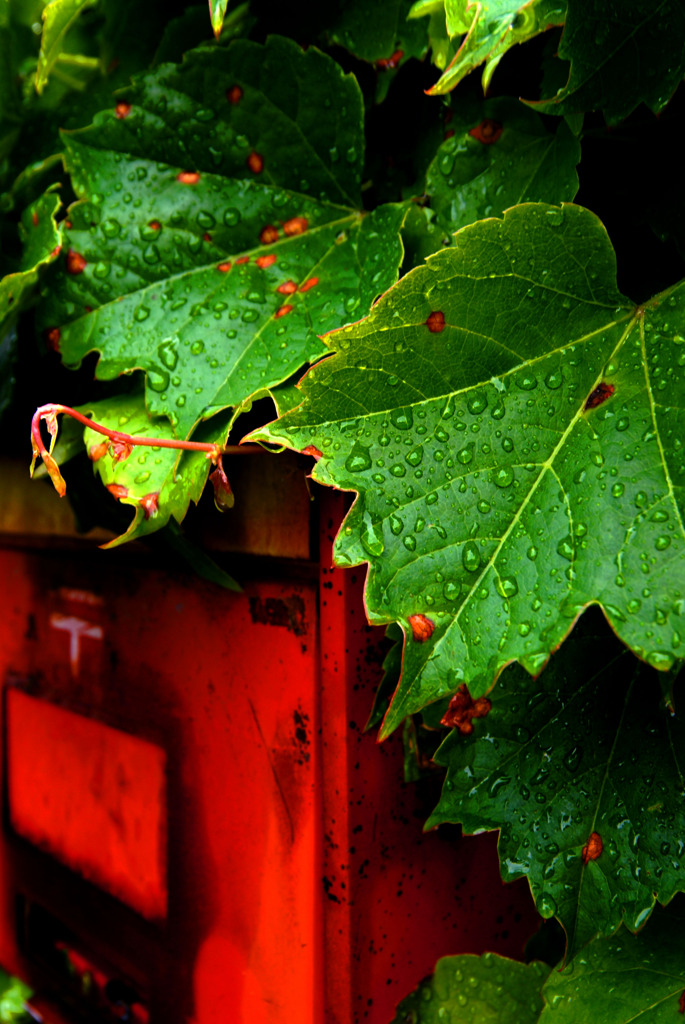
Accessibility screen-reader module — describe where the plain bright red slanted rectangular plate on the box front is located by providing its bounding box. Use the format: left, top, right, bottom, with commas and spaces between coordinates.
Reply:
6, 687, 167, 920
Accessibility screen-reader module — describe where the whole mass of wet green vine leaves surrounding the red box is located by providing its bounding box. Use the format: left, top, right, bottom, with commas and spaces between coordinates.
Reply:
0, 0, 685, 1024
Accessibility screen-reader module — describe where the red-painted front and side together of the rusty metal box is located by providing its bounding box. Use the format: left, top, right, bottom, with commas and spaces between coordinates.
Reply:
0, 481, 538, 1024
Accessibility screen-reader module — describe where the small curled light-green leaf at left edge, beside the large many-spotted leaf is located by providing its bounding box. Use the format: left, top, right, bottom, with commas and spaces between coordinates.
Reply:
0, 189, 61, 333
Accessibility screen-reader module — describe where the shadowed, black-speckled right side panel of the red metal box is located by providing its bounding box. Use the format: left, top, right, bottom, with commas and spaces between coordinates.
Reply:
320, 493, 539, 1024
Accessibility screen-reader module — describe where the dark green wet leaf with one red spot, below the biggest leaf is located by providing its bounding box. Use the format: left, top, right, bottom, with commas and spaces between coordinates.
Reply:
426, 613, 685, 956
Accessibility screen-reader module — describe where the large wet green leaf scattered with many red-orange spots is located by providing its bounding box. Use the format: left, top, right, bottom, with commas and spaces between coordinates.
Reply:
41, 37, 404, 448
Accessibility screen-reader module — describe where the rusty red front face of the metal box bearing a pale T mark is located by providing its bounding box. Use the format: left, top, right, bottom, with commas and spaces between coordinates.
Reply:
0, 551, 323, 1024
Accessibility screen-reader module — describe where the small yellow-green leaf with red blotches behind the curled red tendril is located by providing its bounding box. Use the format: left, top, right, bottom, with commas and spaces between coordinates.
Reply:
79, 393, 230, 548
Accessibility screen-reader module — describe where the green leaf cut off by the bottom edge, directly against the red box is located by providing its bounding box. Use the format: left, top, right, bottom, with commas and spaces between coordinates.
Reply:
392, 953, 550, 1024
